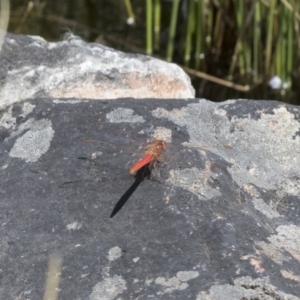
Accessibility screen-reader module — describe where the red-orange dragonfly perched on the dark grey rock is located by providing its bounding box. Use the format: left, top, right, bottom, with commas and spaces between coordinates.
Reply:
130, 140, 167, 175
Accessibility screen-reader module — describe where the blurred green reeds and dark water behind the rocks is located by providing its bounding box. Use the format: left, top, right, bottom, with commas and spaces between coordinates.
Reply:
7, 0, 300, 104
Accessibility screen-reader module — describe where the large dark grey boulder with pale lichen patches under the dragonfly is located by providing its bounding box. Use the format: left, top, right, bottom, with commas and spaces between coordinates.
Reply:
0, 98, 300, 300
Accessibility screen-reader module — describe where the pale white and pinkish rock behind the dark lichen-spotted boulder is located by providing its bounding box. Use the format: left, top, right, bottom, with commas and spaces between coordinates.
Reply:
0, 34, 194, 107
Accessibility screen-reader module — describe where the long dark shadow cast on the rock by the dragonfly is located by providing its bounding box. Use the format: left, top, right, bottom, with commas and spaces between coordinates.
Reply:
110, 164, 151, 218
